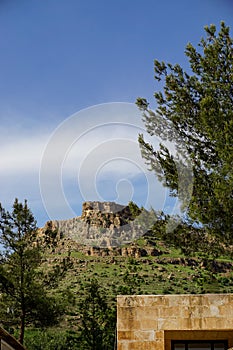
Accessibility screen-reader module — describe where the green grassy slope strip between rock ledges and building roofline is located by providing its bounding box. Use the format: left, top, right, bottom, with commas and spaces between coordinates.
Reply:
44, 240, 233, 304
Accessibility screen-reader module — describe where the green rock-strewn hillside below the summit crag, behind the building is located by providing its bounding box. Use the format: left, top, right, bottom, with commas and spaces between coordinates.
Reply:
26, 201, 233, 349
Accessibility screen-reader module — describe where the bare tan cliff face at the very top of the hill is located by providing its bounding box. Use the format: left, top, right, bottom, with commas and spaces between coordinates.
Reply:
40, 202, 146, 248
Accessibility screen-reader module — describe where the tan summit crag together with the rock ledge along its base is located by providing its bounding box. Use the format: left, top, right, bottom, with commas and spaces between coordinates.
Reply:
36, 201, 233, 266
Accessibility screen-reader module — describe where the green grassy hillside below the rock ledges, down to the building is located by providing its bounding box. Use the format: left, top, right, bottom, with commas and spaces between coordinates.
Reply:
22, 226, 233, 349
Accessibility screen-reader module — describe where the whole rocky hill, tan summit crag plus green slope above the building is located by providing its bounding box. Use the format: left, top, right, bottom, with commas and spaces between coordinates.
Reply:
37, 202, 233, 330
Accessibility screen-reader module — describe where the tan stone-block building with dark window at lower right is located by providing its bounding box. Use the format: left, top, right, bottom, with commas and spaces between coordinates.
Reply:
117, 294, 233, 350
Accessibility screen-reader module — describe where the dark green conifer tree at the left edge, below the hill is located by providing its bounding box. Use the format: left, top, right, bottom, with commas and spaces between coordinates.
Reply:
0, 199, 60, 344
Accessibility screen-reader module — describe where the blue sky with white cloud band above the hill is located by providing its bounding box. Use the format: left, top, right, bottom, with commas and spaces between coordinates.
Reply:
0, 0, 233, 226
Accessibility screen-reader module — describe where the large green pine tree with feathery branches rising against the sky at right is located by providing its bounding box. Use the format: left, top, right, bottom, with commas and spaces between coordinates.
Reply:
137, 22, 233, 243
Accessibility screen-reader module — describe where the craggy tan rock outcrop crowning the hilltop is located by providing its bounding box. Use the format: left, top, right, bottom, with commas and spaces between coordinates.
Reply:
37, 201, 151, 256
